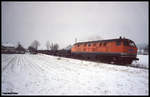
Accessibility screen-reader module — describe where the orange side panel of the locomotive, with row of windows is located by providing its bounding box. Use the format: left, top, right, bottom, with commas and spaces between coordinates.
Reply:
71, 41, 123, 53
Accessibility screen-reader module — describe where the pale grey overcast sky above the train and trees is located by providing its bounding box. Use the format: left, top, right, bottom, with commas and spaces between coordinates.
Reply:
2, 2, 149, 49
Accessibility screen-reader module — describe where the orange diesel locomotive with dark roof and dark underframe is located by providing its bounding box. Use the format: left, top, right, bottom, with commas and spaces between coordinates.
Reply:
71, 37, 138, 64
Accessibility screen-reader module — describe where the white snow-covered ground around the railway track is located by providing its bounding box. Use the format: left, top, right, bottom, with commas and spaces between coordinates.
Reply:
2, 54, 149, 95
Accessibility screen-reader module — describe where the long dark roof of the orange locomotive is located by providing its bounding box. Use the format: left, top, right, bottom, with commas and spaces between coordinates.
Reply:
75, 38, 132, 45
